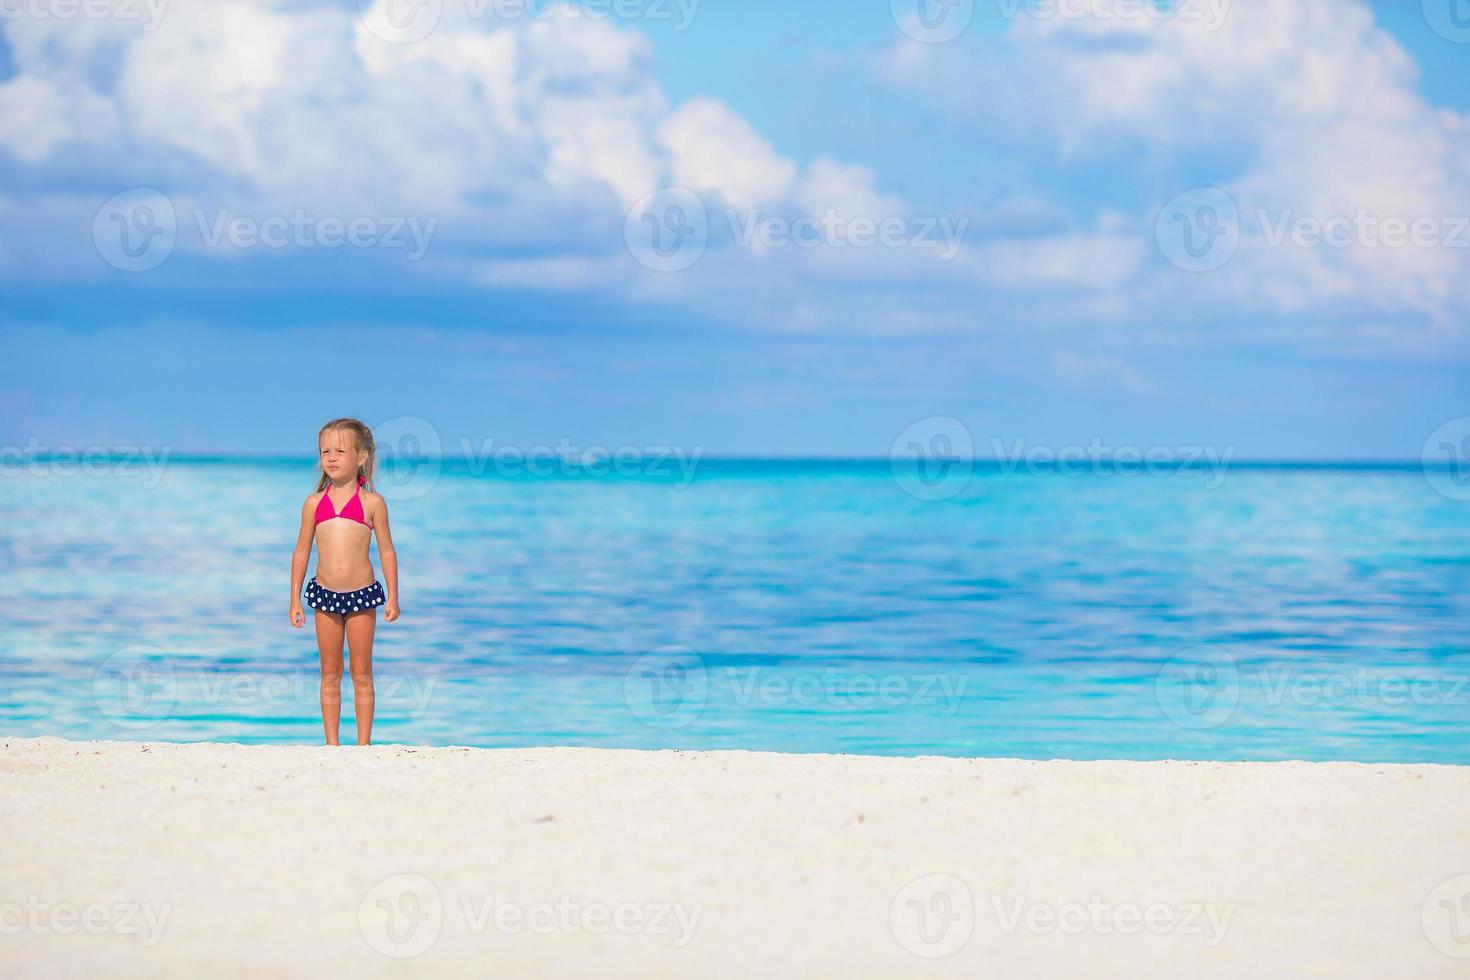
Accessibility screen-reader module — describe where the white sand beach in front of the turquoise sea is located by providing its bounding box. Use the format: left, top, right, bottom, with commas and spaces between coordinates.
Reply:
0, 738, 1470, 980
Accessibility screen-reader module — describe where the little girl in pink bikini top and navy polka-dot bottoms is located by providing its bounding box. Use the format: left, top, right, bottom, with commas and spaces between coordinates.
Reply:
291, 419, 398, 745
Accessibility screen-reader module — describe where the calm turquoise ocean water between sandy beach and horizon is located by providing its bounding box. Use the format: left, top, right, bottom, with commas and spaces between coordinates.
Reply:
0, 460, 1470, 764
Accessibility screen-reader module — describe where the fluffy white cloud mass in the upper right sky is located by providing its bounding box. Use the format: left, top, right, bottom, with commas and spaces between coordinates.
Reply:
873, 0, 1470, 348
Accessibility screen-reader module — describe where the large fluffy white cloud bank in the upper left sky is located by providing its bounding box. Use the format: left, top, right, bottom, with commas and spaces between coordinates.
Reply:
0, 0, 917, 292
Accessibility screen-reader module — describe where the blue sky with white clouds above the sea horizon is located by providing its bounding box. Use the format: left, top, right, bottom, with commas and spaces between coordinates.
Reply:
0, 0, 1470, 458
